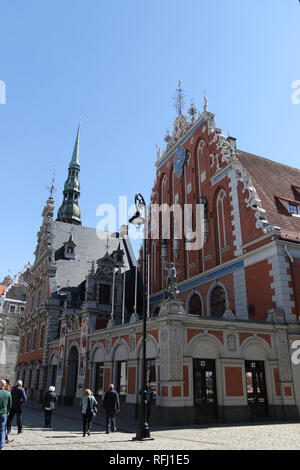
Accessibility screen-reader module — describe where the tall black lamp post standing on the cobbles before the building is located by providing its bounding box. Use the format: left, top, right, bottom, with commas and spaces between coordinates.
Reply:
129, 193, 153, 441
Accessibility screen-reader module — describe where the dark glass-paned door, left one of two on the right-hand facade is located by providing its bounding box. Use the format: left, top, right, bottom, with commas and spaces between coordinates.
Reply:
193, 359, 217, 420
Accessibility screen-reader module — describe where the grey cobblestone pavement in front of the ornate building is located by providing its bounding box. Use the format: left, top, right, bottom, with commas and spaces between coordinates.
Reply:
4, 407, 300, 451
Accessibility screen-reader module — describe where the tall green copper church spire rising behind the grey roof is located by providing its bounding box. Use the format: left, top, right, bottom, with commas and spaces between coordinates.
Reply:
56, 121, 81, 225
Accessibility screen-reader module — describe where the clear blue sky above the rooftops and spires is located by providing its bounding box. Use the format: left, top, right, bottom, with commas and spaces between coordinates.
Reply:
0, 0, 300, 282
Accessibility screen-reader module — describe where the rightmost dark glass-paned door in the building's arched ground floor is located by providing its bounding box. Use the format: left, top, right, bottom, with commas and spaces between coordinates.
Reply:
245, 361, 268, 419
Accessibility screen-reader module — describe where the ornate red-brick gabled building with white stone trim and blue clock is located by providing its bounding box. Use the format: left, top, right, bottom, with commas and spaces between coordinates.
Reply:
18, 93, 300, 425
